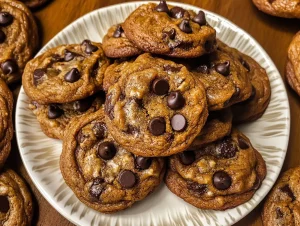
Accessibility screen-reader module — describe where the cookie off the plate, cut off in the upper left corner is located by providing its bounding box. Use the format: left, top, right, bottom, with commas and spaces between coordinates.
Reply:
0, 0, 39, 84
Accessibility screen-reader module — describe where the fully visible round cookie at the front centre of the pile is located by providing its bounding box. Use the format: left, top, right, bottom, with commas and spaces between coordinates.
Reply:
105, 53, 208, 157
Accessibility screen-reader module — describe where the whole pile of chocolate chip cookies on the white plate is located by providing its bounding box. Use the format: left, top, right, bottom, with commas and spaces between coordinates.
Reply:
23, 1, 271, 213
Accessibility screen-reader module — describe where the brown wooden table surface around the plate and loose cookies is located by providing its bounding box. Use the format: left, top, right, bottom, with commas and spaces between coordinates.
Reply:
5, 0, 300, 226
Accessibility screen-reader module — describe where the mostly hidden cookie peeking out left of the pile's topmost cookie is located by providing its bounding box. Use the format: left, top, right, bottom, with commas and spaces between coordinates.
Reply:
103, 24, 142, 58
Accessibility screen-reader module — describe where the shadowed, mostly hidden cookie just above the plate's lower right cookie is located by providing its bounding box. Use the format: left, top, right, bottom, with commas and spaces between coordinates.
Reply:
191, 108, 232, 148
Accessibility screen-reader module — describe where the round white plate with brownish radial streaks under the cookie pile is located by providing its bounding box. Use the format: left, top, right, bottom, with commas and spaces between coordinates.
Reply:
16, 2, 290, 226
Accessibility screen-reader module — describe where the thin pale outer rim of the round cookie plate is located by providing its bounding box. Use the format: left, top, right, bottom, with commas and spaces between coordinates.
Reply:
14, 1, 291, 225
